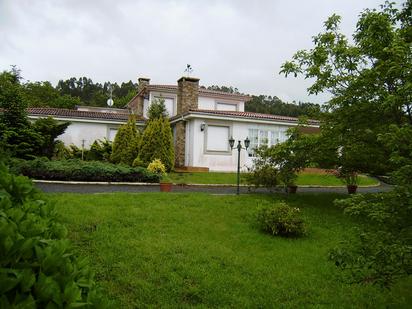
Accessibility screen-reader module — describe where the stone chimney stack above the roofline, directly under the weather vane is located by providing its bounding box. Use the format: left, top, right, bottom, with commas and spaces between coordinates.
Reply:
177, 77, 199, 115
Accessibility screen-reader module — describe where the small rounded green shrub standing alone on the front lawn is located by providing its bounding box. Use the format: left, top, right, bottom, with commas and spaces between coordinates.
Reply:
257, 203, 306, 236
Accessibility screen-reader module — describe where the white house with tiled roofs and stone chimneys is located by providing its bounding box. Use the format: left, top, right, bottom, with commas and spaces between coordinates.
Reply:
29, 77, 318, 171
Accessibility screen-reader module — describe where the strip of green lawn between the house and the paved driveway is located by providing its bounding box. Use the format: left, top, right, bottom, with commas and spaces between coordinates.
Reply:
169, 172, 378, 186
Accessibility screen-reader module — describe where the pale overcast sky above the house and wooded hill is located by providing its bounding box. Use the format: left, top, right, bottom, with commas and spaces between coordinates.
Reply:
0, 0, 383, 103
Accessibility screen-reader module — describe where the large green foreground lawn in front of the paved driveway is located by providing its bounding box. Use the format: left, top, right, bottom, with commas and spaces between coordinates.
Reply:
50, 193, 412, 308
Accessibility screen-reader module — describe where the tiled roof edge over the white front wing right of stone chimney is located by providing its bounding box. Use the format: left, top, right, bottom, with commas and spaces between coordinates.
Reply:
176, 109, 319, 126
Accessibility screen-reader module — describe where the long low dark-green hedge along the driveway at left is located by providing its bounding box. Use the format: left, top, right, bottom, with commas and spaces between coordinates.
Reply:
12, 158, 159, 182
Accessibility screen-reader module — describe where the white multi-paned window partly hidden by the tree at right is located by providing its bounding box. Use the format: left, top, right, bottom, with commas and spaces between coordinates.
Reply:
248, 129, 287, 157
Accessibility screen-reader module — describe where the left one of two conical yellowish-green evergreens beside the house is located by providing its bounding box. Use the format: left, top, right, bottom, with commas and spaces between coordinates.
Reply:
110, 115, 140, 166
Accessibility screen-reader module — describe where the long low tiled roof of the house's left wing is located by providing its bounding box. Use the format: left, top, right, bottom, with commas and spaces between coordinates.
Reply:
27, 107, 143, 122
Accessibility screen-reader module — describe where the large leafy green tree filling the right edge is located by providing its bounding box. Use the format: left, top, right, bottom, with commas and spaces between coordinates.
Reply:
281, 0, 412, 287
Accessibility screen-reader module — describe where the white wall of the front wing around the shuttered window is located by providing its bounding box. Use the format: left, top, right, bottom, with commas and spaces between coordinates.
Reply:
186, 119, 290, 172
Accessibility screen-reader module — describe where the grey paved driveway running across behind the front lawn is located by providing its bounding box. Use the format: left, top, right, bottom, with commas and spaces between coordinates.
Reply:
36, 182, 392, 194
